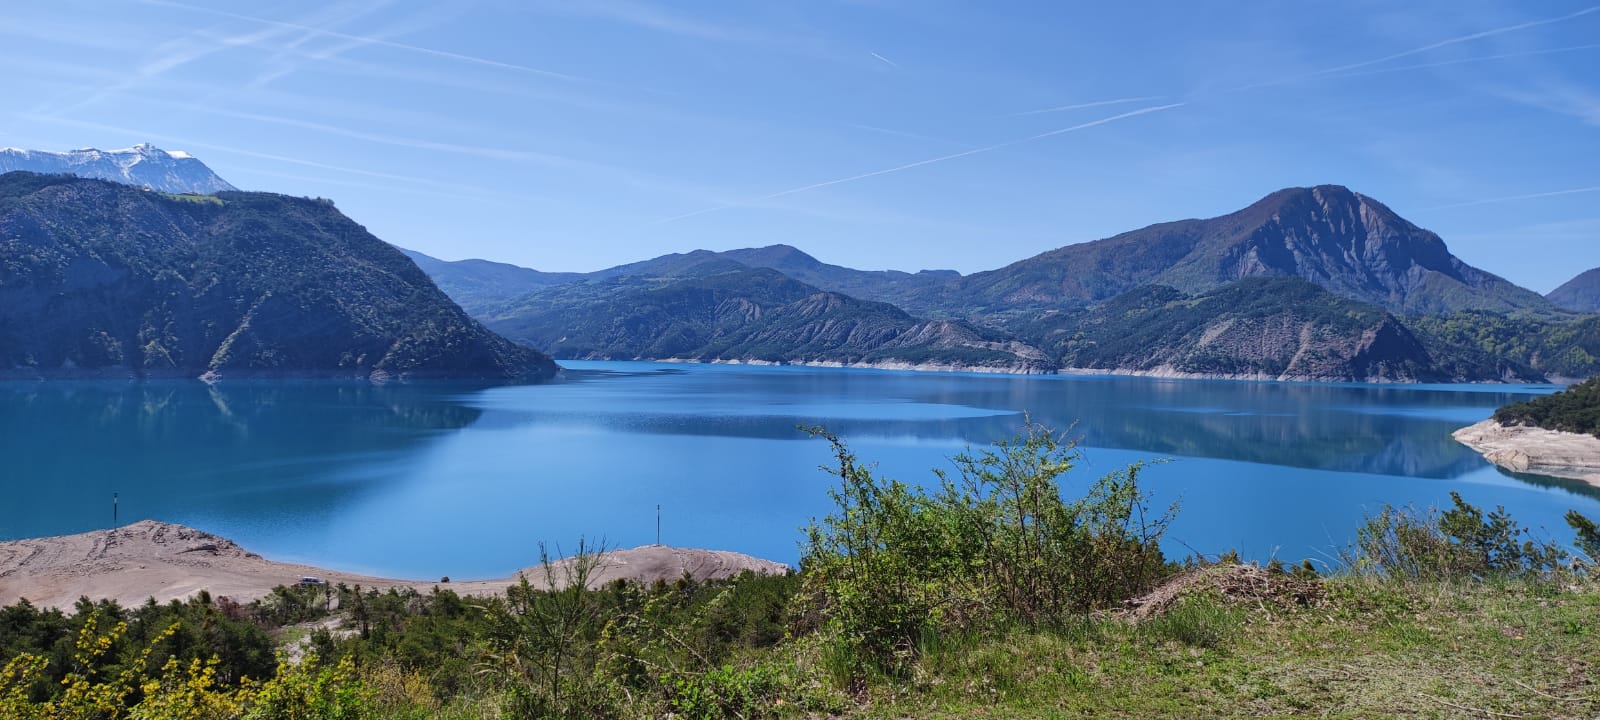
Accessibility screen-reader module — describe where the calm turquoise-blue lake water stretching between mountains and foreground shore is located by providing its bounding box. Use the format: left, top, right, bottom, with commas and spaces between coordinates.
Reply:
0, 362, 1600, 579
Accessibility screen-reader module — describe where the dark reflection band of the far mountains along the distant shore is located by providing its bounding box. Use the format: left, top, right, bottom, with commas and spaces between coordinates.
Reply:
502, 363, 1549, 478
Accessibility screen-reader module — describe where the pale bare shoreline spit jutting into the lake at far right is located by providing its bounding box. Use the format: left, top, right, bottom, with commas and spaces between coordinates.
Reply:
1450, 418, 1600, 488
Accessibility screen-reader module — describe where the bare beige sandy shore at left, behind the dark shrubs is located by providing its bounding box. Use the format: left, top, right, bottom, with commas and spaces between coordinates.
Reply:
0, 520, 787, 610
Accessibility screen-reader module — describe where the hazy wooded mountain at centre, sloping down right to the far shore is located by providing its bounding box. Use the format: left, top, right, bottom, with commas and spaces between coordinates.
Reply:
483, 260, 1053, 373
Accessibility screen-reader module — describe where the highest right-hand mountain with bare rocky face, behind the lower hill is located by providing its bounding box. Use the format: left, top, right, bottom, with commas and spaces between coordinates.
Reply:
926, 186, 1555, 315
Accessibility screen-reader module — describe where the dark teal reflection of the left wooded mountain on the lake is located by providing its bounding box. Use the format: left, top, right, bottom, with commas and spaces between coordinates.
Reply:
0, 381, 482, 538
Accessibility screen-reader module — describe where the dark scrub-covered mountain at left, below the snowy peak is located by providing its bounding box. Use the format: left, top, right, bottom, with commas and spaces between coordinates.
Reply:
0, 173, 557, 379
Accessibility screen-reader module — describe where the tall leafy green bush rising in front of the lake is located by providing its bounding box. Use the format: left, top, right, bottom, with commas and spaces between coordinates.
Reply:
800, 422, 1173, 677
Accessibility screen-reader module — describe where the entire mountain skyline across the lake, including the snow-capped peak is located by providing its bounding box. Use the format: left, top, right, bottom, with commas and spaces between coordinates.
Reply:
0, 146, 1600, 382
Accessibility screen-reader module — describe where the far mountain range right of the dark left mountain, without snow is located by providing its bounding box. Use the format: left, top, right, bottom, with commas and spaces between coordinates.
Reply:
410, 186, 1600, 382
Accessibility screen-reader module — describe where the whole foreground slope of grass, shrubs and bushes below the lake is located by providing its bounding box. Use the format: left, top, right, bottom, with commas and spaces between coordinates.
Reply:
0, 429, 1600, 720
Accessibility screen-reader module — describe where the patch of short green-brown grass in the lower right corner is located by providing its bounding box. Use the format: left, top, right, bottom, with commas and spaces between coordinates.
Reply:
856, 578, 1600, 718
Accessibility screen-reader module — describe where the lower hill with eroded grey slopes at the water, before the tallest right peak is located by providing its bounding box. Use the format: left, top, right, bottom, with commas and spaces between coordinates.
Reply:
1010, 277, 1450, 382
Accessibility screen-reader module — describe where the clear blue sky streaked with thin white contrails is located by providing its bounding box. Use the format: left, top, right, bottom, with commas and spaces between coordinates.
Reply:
0, 0, 1600, 291
